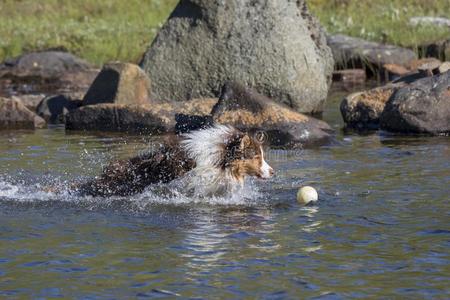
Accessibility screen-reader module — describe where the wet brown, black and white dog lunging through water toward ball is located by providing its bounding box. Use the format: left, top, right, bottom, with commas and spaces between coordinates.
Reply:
76, 124, 274, 197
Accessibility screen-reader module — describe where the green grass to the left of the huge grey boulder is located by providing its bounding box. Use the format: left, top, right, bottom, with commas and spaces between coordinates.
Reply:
0, 0, 177, 65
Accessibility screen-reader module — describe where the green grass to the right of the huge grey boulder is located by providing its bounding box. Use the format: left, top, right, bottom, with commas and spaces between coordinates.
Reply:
308, 0, 450, 49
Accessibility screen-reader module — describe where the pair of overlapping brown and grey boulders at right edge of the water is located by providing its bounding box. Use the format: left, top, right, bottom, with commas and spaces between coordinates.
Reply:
340, 67, 450, 135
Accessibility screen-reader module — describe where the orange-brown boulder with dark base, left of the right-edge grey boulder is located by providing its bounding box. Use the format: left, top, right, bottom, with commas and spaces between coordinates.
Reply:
340, 84, 401, 130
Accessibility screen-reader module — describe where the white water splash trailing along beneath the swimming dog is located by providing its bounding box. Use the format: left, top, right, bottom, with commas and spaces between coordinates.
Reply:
0, 172, 267, 212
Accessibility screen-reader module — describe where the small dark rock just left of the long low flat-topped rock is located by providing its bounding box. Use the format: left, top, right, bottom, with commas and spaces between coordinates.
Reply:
36, 95, 82, 124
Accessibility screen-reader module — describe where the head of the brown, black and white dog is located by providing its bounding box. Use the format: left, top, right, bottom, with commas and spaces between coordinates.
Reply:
220, 131, 274, 182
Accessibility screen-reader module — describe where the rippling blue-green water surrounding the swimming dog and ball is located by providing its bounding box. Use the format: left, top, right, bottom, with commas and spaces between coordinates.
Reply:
0, 86, 450, 299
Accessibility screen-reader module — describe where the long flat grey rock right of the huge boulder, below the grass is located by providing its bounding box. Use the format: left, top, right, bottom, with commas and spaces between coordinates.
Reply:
328, 34, 417, 73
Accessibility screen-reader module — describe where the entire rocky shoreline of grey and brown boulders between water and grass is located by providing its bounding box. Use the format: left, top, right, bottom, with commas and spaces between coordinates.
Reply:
0, 0, 450, 147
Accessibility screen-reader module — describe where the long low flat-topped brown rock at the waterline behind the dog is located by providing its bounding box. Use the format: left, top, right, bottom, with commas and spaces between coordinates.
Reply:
66, 99, 217, 134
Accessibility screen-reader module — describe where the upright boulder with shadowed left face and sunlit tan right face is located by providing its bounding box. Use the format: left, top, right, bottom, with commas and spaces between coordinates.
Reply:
83, 62, 151, 105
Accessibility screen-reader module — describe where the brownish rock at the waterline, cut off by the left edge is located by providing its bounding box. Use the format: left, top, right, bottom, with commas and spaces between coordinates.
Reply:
0, 97, 45, 129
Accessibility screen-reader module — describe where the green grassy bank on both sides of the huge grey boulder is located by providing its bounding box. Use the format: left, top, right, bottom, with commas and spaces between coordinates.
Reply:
0, 0, 450, 65
